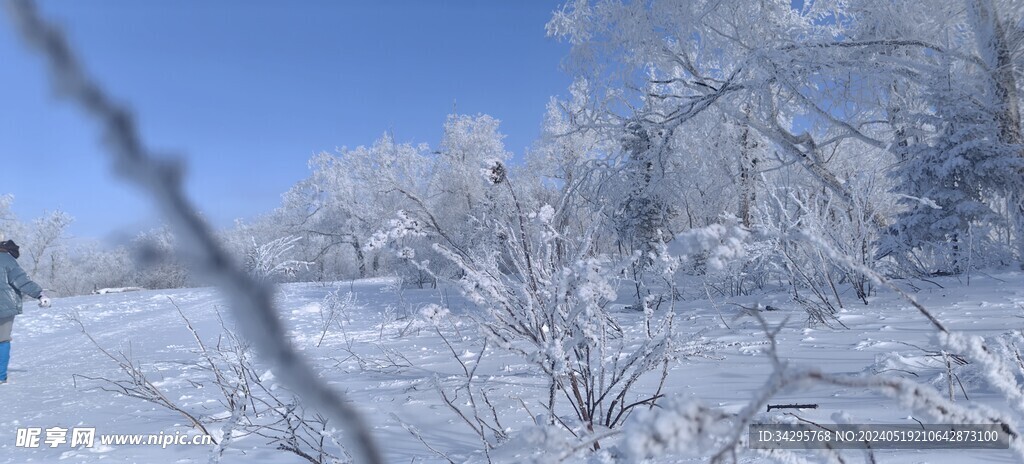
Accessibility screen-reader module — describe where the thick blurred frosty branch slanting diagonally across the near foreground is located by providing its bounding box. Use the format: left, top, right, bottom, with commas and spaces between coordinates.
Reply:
7, 0, 383, 464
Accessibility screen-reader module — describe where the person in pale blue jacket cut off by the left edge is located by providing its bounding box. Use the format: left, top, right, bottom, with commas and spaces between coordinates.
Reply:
0, 240, 50, 384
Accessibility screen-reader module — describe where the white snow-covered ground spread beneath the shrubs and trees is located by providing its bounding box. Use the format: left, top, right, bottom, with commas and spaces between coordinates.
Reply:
0, 272, 1024, 463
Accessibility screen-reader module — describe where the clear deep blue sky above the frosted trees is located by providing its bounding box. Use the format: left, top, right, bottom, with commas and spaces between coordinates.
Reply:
0, 0, 570, 240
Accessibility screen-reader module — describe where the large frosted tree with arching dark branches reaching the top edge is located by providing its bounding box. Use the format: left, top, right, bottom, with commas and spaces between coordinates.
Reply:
548, 1, 887, 245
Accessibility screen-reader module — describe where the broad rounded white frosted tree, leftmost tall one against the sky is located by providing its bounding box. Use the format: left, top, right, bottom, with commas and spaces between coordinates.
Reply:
272, 134, 433, 280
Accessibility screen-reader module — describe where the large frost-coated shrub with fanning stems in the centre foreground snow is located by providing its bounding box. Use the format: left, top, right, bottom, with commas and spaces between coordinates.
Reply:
425, 180, 675, 450
